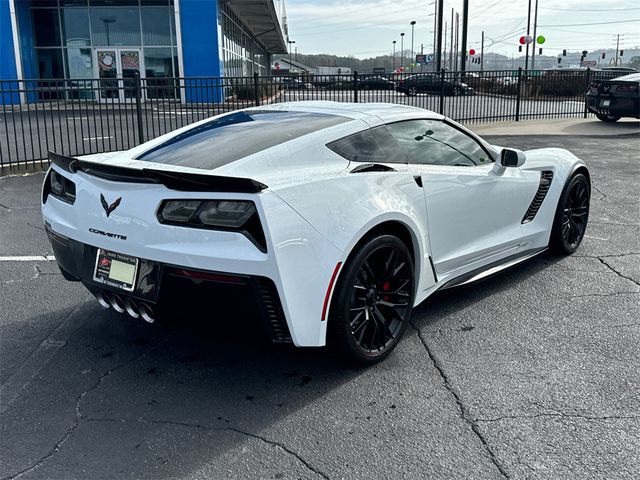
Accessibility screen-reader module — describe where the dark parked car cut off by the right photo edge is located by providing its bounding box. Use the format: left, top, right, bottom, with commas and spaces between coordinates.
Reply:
586, 73, 640, 122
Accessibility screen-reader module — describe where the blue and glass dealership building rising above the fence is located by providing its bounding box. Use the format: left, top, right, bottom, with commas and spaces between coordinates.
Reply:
0, 0, 287, 100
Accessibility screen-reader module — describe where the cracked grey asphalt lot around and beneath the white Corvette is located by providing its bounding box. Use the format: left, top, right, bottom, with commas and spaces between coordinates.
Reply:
0, 122, 640, 479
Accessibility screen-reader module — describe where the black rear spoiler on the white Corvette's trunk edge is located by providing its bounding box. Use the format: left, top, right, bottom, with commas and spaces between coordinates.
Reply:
49, 152, 268, 193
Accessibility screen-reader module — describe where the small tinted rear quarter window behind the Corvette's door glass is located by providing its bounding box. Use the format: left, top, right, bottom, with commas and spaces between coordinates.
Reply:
327, 125, 407, 163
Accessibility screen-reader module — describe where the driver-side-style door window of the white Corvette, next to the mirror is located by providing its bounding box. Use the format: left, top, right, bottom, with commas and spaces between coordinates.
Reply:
387, 120, 492, 166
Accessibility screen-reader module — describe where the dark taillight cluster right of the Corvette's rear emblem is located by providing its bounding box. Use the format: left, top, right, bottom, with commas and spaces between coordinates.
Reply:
157, 200, 267, 252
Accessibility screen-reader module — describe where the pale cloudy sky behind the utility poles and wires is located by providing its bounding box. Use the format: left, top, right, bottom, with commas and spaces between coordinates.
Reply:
280, 0, 640, 58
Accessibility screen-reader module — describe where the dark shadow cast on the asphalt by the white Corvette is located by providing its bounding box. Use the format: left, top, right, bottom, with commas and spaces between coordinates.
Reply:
0, 251, 558, 478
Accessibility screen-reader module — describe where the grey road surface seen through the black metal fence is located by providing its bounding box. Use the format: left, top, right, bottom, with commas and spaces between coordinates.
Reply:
0, 90, 584, 169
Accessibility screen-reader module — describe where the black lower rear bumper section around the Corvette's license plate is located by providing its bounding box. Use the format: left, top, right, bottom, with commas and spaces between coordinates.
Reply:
45, 225, 292, 343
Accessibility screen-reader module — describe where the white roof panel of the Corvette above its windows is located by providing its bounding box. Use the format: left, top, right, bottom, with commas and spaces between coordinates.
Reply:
248, 100, 444, 126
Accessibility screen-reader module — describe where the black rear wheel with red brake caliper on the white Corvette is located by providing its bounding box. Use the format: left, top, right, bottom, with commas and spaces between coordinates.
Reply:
327, 235, 415, 365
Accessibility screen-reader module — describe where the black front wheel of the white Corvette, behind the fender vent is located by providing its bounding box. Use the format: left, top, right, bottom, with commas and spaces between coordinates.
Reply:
549, 173, 591, 255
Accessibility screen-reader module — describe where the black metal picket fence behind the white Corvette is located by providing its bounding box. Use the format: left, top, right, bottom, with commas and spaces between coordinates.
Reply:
0, 69, 608, 173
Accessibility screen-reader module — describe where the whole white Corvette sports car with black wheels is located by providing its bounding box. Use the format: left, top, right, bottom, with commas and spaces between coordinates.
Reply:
42, 102, 590, 363
